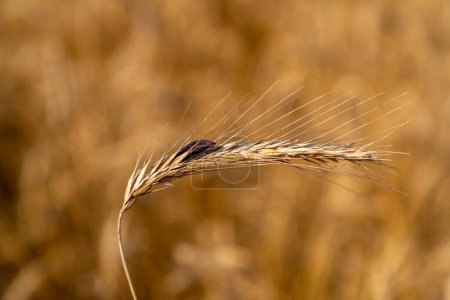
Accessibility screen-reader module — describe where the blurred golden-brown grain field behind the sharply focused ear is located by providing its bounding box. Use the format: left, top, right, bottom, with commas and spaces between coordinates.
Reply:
0, 0, 450, 299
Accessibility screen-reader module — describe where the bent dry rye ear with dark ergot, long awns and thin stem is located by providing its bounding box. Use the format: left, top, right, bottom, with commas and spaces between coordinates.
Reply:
117, 88, 405, 299
